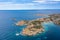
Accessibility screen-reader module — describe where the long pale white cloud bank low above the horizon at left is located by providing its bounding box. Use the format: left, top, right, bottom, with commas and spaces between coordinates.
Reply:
0, 2, 34, 10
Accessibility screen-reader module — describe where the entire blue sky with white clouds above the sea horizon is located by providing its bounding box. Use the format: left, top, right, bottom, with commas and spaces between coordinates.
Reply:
0, 0, 60, 10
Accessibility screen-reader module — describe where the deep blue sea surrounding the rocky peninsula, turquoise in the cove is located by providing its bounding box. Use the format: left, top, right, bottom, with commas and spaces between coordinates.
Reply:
0, 9, 60, 40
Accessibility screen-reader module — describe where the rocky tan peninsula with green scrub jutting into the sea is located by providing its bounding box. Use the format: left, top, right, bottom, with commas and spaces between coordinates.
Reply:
16, 14, 60, 36
